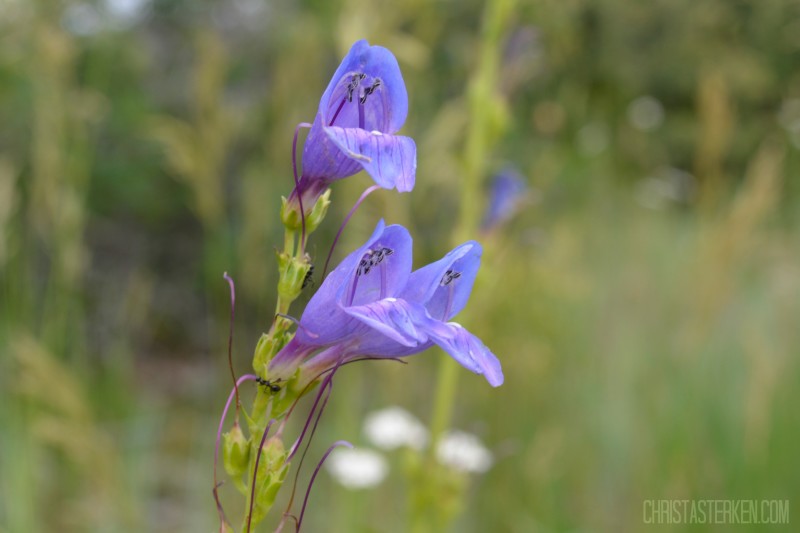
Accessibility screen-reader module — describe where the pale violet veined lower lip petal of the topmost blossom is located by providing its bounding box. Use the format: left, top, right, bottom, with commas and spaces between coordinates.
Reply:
325, 127, 417, 192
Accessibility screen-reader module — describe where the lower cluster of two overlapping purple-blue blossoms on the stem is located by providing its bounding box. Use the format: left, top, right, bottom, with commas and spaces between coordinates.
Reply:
269, 221, 503, 387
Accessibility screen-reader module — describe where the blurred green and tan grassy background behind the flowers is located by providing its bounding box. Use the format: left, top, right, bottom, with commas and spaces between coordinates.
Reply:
0, 0, 800, 533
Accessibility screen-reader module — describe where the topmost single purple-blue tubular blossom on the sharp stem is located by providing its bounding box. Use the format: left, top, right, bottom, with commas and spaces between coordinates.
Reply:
292, 40, 417, 207
